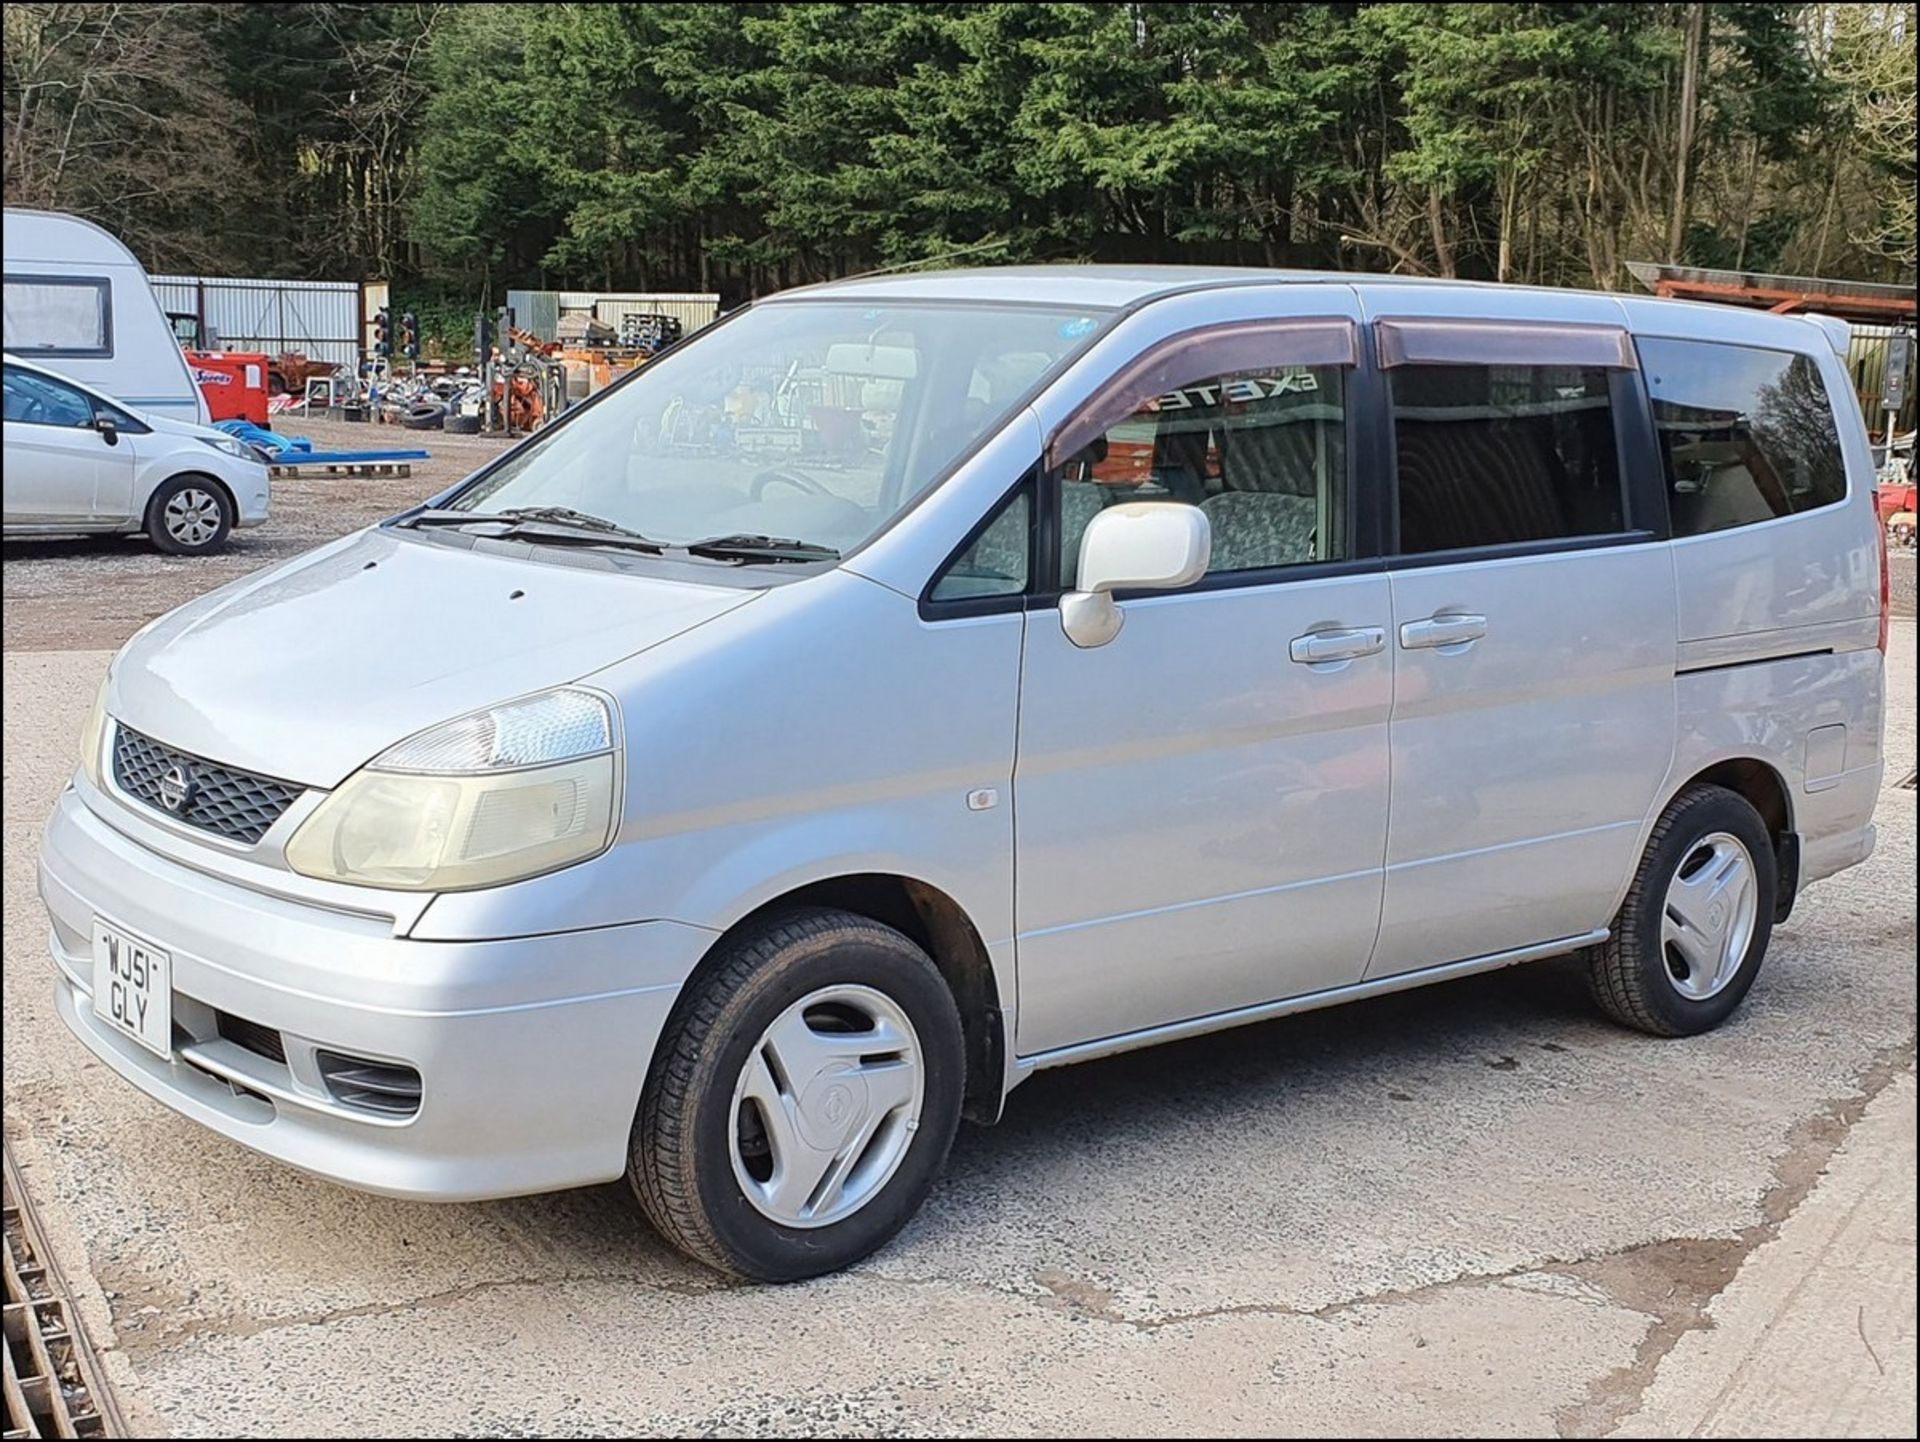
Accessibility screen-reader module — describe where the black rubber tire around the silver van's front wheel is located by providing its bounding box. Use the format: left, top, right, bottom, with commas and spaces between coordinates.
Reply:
626, 908, 966, 1283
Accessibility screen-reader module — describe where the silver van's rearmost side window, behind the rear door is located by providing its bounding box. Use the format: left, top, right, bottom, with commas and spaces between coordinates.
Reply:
1640, 338, 1847, 536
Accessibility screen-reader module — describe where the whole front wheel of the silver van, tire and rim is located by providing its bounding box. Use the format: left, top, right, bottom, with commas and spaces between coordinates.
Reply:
628, 910, 966, 1281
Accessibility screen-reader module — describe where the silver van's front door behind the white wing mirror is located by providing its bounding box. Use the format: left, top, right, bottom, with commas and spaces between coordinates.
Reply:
1014, 323, 1394, 1056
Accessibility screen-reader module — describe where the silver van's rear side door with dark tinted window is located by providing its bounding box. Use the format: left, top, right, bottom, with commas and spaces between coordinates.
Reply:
1367, 323, 1676, 977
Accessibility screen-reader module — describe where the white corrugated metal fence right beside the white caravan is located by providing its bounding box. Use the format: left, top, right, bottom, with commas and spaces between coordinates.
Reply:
154, 275, 386, 367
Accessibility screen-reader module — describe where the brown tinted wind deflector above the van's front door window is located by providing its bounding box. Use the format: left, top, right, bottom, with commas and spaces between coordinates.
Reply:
1046, 315, 1359, 470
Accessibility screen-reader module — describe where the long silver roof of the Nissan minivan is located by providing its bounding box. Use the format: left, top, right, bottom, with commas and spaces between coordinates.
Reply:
768, 265, 1845, 353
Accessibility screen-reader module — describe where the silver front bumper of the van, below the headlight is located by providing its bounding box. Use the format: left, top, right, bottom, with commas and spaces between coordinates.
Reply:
40, 787, 712, 1202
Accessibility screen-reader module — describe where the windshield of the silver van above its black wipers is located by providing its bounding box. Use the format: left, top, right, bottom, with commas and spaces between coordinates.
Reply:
445, 300, 1104, 559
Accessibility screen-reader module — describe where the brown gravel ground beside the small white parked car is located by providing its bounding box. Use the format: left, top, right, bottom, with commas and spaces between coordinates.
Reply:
6, 419, 507, 651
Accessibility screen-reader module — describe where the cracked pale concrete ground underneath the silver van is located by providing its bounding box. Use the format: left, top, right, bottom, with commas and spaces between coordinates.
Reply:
0, 622, 1914, 1436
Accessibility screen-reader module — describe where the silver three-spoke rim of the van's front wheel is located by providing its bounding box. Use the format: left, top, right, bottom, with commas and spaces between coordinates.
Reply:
733, 987, 924, 1227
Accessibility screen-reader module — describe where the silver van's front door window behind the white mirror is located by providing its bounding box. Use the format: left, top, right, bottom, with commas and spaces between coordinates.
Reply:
1060, 359, 1348, 589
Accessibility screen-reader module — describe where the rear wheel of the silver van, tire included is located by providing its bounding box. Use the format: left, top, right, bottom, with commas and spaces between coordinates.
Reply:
1588, 785, 1778, 1037
